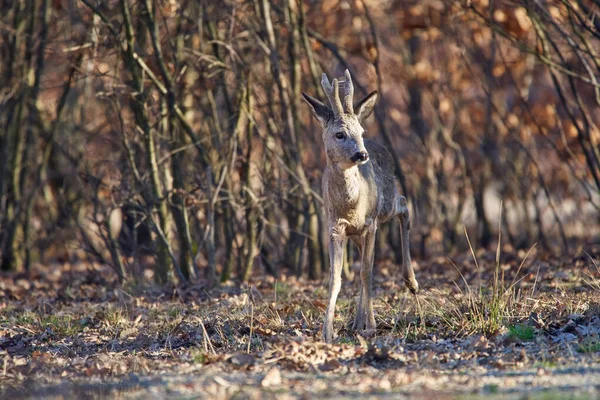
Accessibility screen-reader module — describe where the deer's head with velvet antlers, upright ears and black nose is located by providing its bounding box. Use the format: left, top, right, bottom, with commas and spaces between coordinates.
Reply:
302, 70, 377, 169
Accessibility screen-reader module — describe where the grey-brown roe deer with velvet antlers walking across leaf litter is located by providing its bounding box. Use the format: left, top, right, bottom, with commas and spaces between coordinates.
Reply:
302, 70, 419, 343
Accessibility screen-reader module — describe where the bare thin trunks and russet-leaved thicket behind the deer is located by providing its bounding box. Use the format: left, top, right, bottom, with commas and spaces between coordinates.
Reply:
0, 0, 600, 283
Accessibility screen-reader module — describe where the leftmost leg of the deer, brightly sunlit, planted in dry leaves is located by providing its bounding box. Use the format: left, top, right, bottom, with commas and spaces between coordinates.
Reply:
323, 227, 346, 343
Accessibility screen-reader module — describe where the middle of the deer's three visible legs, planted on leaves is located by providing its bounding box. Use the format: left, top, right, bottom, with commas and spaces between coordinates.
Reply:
352, 226, 377, 331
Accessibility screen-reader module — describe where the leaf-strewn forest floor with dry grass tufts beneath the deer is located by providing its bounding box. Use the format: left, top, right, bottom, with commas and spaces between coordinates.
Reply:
0, 242, 600, 399
